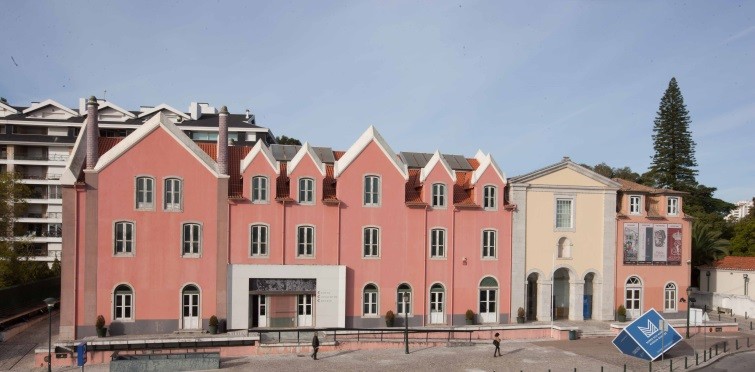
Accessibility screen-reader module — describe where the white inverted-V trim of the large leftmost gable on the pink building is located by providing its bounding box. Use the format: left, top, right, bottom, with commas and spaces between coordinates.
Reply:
94, 112, 228, 178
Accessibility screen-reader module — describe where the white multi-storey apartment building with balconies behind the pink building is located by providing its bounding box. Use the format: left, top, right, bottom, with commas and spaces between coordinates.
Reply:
0, 98, 275, 262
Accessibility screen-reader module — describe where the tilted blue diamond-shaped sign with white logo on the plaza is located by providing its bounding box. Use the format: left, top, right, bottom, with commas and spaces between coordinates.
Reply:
613, 309, 682, 360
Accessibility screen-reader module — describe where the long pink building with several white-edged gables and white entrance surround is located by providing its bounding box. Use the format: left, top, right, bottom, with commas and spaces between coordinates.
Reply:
61, 102, 512, 339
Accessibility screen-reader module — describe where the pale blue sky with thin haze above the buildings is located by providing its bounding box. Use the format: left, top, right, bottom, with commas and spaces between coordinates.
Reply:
0, 1, 755, 201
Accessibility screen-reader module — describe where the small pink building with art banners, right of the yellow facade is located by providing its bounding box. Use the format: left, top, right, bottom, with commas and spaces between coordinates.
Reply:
615, 179, 692, 319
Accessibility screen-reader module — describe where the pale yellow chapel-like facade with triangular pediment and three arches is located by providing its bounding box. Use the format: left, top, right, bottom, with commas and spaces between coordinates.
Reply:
509, 157, 621, 321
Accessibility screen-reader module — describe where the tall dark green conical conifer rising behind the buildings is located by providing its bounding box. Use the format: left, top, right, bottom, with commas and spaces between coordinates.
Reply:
648, 78, 697, 191
